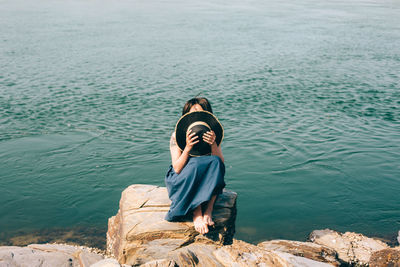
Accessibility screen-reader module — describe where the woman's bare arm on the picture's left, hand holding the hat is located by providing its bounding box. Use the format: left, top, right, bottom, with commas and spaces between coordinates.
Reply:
169, 131, 199, 174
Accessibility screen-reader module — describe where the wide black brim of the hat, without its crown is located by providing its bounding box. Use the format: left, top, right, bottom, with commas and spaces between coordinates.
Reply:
175, 111, 224, 156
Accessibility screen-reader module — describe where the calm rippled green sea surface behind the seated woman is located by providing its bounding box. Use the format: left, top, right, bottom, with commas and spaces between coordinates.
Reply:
0, 0, 400, 246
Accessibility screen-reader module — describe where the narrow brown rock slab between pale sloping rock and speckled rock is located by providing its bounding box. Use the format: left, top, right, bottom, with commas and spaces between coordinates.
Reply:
257, 240, 340, 266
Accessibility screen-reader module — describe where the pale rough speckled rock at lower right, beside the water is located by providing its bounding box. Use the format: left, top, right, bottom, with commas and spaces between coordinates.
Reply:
310, 229, 389, 266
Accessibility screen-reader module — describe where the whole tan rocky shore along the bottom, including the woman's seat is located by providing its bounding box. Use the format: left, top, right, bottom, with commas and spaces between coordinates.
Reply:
0, 184, 400, 267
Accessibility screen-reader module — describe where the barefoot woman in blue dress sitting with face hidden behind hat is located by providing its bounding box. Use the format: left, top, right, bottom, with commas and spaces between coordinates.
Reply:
165, 98, 225, 234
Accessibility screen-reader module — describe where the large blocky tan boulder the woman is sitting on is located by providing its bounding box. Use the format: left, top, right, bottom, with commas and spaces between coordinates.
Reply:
107, 184, 237, 265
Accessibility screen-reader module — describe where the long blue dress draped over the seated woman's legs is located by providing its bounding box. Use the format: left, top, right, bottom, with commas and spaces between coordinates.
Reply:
165, 155, 226, 222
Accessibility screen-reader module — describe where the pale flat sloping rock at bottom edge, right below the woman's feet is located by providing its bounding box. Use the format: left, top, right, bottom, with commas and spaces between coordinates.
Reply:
213, 240, 332, 267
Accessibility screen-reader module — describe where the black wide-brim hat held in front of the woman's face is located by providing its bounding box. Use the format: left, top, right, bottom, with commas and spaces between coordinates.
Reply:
175, 111, 224, 156
